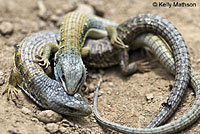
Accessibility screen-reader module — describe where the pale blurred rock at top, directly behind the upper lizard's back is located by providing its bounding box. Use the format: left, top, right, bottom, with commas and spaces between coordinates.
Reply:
75, 4, 95, 15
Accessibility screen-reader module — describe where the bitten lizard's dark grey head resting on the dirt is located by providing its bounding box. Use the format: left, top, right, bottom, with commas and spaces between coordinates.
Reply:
49, 84, 92, 116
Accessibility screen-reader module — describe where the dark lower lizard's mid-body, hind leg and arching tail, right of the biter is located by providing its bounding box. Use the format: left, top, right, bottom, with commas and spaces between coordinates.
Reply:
84, 14, 190, 127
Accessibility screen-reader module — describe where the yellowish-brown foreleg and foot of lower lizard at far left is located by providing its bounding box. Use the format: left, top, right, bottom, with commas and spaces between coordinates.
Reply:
3, 67, 23, 101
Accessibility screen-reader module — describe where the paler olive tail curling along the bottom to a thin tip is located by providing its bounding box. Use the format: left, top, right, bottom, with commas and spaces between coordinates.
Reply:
94, 33, 200, 134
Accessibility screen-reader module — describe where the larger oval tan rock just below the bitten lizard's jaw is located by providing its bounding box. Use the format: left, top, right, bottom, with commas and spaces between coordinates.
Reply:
37, 110, 62, 123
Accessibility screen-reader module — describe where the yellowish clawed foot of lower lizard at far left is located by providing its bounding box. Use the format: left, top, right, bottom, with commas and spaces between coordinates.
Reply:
2, 84, 19, 101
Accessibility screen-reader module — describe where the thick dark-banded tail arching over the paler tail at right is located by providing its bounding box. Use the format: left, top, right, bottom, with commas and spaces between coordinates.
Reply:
117, 14, 190, 126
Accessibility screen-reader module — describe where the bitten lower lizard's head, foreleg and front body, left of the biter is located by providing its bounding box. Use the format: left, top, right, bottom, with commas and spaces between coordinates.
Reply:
3, 31, 91, 116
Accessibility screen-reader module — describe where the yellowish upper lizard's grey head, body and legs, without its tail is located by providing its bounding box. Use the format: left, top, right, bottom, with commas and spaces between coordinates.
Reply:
36, 12, 125, 95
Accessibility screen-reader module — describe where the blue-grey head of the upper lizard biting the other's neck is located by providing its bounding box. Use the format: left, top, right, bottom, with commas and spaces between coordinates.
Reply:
54, 53, 87, 95
